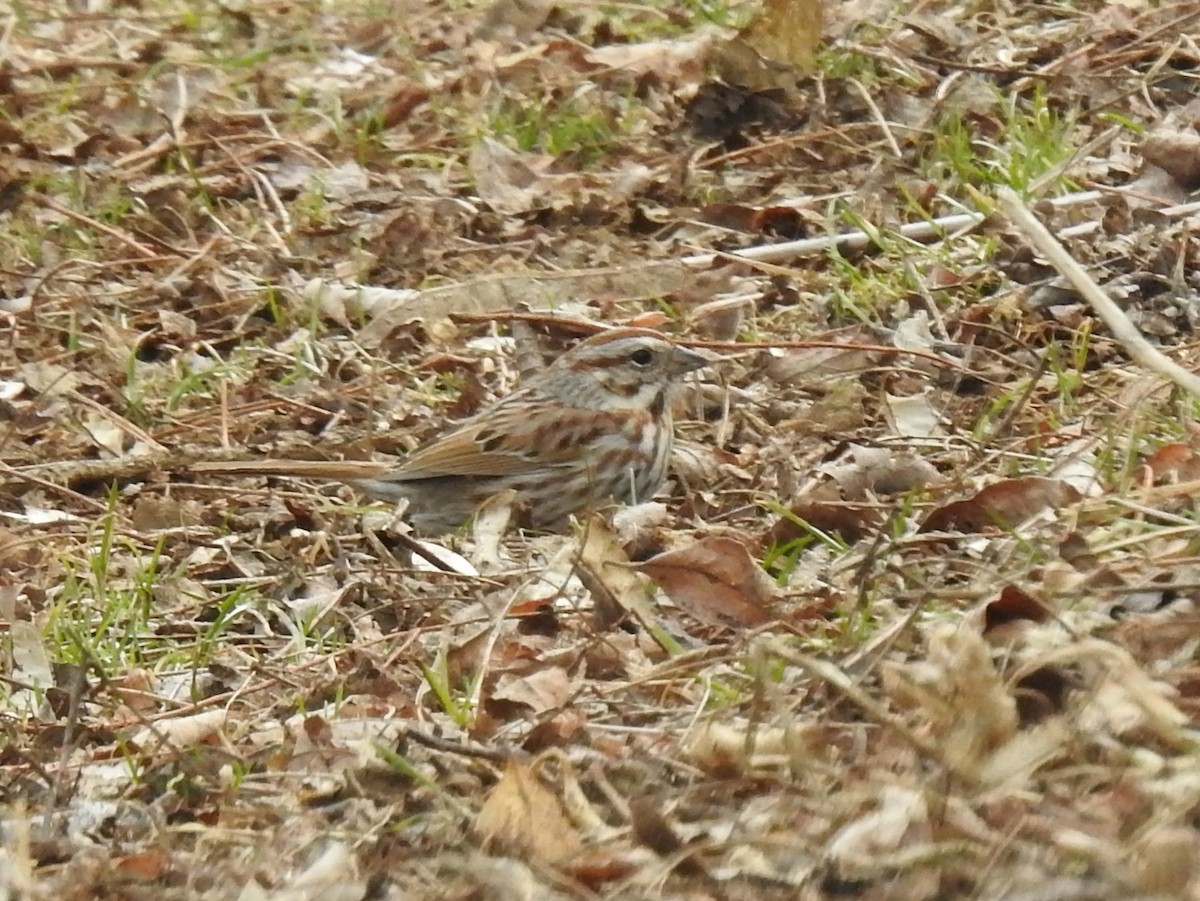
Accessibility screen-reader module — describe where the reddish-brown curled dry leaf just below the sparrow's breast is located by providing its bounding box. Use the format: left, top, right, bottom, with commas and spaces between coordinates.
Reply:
634, 537, 775, 626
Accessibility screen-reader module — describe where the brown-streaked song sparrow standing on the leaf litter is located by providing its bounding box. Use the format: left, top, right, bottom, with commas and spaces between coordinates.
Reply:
193, 328, 709, 533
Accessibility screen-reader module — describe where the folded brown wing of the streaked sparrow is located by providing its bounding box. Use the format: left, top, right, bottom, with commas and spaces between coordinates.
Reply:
388, 404, 578, 481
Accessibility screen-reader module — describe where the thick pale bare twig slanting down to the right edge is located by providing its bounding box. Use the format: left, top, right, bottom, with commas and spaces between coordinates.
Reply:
996, 187, 1200, 395
